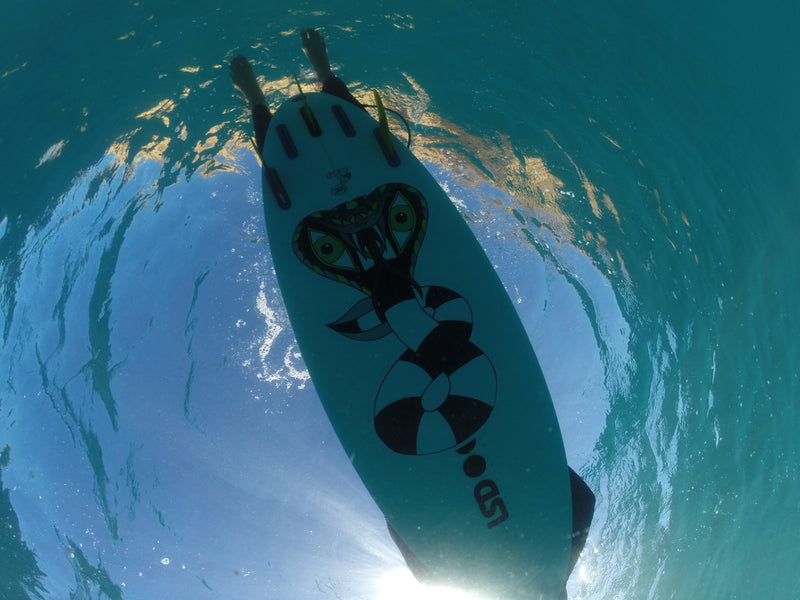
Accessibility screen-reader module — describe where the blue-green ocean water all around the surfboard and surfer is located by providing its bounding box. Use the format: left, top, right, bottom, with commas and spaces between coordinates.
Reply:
0, 0, 800, 600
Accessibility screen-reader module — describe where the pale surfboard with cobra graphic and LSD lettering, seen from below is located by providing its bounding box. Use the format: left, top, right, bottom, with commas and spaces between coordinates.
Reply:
262, 94, 572, 600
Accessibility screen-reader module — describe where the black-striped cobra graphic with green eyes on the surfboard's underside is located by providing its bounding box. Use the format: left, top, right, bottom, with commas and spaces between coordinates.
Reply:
292, 183, 497, 455
